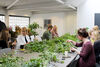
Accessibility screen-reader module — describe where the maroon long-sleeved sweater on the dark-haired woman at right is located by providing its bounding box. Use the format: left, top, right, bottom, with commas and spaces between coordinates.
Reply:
76, 41, 96, 67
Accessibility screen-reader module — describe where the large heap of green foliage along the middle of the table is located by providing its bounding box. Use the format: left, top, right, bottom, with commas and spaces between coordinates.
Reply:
25, 33, 79, 53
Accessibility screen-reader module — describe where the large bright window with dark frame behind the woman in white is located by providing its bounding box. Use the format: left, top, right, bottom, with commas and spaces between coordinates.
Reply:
9, 16, 30, 30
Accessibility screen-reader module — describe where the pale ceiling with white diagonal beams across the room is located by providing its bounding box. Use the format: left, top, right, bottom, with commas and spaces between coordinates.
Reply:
0, 0, 85, 13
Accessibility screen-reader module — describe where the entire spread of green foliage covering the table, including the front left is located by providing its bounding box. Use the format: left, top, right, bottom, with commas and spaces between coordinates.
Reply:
0, 33, 79, 67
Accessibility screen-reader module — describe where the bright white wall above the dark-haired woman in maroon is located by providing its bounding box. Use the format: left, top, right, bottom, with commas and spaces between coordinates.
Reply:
77, 0, 100, 28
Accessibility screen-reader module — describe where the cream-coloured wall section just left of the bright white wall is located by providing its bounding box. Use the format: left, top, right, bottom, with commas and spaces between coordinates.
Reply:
64, 12, 77, 34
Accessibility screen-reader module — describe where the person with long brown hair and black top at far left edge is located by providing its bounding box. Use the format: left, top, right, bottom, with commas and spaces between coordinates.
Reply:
0, 29, 9, 49
